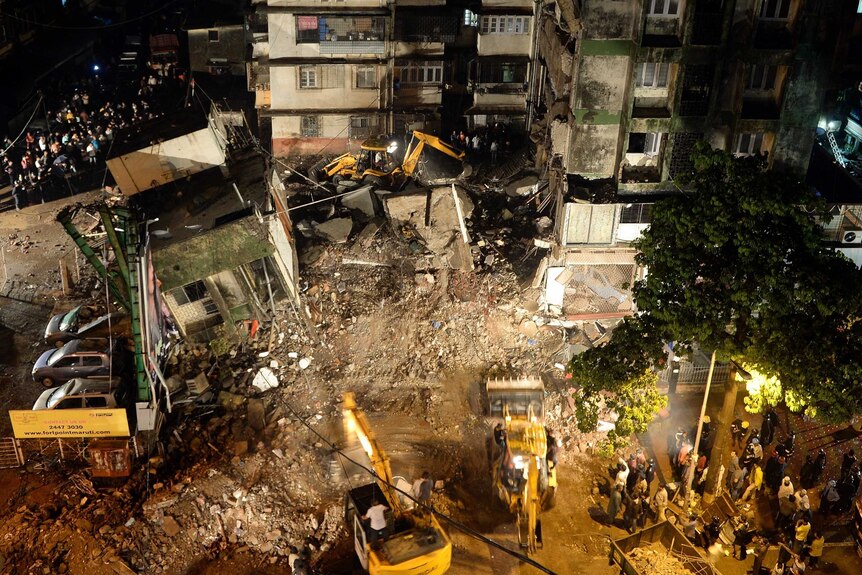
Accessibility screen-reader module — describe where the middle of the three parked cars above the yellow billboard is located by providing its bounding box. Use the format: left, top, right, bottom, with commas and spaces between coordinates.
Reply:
32, 339, 119, 387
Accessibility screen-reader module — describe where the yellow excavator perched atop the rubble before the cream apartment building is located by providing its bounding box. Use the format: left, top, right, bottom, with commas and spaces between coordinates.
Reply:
309, 131, 469, 189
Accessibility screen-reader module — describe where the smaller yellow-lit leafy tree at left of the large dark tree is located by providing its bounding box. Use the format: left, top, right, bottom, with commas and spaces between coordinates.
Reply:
569, 317, 667, 452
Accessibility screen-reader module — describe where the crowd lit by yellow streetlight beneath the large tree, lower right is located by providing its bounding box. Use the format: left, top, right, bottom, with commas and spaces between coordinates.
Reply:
605, 406, 862, 575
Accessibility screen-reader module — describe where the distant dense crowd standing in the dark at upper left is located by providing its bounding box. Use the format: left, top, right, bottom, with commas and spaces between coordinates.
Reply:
0, 65, 185, 210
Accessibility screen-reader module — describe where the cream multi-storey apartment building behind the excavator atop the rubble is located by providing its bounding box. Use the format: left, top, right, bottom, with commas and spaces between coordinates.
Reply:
248, 0, 534, 156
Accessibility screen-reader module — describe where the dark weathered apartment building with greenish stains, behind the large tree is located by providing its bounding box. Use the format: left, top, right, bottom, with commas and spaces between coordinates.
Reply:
538, 0, 856, 322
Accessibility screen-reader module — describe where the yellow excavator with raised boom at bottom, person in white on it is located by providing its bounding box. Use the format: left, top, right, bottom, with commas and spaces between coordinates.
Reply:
342, 393, 452, 575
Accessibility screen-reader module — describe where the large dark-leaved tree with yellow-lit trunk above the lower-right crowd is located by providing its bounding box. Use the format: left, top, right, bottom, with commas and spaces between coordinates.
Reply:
633, 144, 862, 500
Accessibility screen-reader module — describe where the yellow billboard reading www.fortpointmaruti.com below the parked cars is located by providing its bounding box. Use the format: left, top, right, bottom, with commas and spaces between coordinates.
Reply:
9, 409, 129, 439
